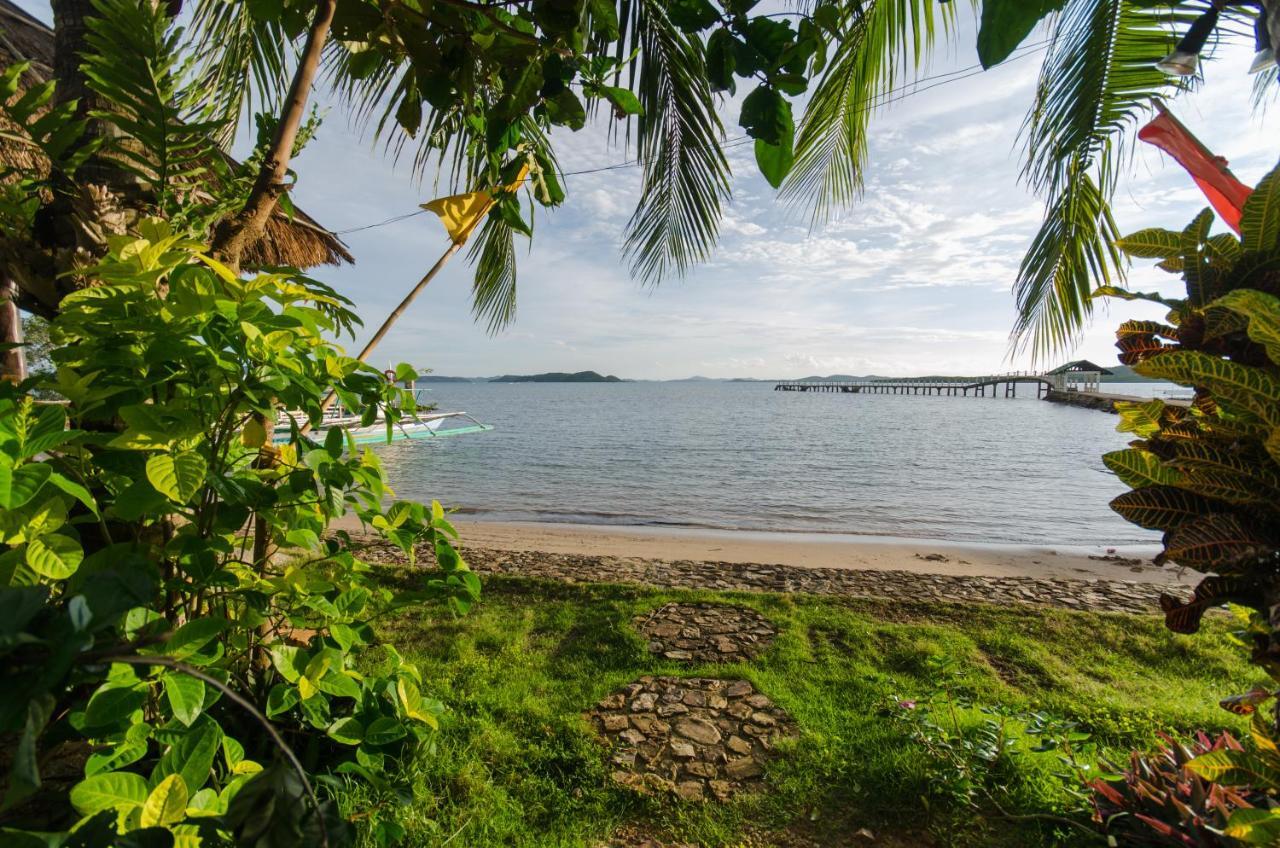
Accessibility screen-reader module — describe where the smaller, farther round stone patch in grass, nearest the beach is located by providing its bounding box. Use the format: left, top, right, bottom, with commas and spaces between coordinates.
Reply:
635, 603, 778, 662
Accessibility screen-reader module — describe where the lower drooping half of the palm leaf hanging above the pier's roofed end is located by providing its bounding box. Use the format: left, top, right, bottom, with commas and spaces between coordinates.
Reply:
1012, 160, 1123, 360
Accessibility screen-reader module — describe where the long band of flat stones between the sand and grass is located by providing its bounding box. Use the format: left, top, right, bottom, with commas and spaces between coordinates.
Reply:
365, 546, 1190, 615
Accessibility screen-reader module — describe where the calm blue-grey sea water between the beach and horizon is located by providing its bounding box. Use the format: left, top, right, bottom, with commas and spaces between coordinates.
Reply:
378, 382, 1177, 546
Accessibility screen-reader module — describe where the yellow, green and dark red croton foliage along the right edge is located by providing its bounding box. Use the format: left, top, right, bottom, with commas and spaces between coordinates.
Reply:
1097, 159, 1280, 844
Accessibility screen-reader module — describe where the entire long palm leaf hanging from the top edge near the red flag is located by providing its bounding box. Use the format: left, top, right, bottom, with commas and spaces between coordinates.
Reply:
1014, 0, 1194, 359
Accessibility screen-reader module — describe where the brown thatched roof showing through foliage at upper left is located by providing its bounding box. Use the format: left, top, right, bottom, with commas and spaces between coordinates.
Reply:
0, 0, 356, 268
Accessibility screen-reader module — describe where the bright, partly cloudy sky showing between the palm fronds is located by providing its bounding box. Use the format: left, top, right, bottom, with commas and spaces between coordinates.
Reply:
17, 0, 1280, 379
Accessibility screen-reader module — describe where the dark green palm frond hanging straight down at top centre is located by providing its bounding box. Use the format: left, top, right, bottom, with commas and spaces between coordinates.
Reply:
623, 0, 731, 284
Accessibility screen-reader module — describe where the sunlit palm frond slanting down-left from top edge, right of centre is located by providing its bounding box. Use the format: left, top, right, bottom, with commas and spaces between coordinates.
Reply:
781, 0, 956, 227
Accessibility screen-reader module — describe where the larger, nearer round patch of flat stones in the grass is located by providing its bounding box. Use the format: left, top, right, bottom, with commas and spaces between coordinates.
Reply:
588, 676, 795, 801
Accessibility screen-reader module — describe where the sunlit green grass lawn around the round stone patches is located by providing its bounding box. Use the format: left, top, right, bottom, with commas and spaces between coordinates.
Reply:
344, 578, 1257, 848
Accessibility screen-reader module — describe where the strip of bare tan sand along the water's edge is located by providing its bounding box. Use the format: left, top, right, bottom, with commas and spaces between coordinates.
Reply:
338, 519, 1201, 587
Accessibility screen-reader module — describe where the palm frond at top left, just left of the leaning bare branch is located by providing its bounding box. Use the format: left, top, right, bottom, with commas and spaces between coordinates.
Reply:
183, 0, 291, 150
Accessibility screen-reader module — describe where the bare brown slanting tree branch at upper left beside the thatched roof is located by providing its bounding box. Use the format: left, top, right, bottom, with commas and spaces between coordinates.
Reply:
212, 0, 338, 270
